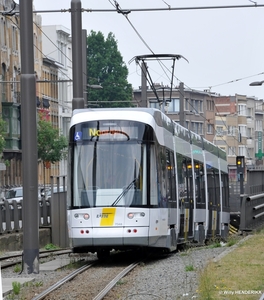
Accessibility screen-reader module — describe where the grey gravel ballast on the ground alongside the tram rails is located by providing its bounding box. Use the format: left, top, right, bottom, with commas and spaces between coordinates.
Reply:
2, 246, 239, 300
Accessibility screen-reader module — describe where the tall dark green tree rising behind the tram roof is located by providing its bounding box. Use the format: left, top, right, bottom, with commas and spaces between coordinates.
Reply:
87, 31, 133, 107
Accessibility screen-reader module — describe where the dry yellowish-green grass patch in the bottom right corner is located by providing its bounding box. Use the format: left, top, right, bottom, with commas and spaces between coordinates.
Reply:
198, 230, 264, 300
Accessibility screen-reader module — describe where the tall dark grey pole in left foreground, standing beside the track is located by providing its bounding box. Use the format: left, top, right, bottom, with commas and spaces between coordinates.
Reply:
19, 0, 39, 274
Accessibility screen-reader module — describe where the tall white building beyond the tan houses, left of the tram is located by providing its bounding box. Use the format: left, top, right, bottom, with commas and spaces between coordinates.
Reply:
42, 25, 73, 180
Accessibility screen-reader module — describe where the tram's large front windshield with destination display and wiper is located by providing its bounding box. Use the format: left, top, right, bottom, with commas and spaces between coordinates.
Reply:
68, 120, 152, 208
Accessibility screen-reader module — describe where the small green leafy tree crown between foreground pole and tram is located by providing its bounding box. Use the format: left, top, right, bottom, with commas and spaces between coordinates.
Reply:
37, 120, 68, 163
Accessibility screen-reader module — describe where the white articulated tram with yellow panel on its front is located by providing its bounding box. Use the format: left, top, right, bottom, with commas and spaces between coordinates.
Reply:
67, 108, 229, 257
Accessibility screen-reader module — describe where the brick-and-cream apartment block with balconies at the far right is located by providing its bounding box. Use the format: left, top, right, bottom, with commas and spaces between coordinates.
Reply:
214, 94, 263, 180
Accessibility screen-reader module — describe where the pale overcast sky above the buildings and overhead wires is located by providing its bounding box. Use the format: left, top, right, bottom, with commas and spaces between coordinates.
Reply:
33, 0, 264, 99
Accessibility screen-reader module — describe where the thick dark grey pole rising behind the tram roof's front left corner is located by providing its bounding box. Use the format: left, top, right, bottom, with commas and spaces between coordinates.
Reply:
71, 0, 84, 110
